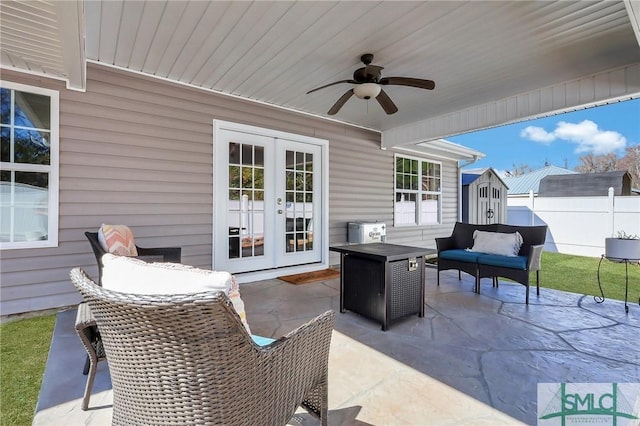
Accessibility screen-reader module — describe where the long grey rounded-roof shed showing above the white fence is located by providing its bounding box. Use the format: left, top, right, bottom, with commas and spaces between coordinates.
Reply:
538, 171, 634, 197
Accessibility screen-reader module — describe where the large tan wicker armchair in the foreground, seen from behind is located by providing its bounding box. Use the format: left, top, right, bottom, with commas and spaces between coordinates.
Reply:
71, 268, 334, 425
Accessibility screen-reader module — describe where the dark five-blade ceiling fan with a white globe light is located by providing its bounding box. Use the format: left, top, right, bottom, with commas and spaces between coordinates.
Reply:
307, 53, 436, 115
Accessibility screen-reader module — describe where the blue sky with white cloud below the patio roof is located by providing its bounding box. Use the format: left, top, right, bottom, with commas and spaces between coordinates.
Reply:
446, 99, 640, 172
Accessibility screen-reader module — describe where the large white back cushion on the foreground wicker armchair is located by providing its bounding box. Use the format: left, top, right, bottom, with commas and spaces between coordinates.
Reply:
102, 253, 251, 334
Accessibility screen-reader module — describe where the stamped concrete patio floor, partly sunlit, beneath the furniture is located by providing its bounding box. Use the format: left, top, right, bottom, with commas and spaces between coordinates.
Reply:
33, 268, 640, 425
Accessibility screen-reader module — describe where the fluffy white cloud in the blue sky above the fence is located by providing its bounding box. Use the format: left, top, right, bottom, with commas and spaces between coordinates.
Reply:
520, 120, 627, 155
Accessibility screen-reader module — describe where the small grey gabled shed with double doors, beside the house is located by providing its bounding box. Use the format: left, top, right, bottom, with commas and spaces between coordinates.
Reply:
462, 167, 509, 224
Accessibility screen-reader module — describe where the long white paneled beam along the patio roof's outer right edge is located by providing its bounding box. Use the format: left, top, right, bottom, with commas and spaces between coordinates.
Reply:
382, 62, 640, 149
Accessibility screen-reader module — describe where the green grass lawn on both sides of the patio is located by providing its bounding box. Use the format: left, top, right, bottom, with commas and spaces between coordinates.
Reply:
0, 252, 640, 425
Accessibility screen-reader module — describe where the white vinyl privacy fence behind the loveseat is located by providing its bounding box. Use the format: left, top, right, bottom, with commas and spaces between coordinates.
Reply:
507, 188, 640, 257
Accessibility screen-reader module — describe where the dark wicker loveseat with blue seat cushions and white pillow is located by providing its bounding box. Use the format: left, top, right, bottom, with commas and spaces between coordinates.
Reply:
436, 222, 547, 304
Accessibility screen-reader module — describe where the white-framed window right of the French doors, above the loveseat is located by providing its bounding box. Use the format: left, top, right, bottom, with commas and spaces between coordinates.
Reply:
393, 155, 442, 226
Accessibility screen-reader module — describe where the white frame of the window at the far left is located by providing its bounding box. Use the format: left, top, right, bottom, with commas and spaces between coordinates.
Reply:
0, 80, 60, 250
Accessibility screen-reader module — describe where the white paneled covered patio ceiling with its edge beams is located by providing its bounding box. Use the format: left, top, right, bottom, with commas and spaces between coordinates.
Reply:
0, 0, 640, 147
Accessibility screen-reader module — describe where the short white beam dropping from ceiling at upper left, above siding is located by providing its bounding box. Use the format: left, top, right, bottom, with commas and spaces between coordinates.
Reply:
54, 0, 87, 92
